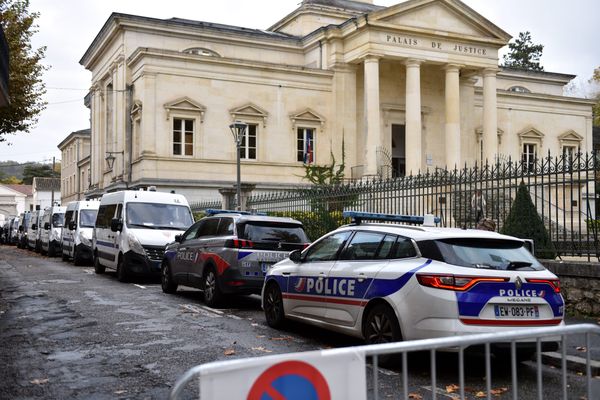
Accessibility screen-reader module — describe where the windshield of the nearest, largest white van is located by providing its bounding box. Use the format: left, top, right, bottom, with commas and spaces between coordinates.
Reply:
126, 203, 194, 230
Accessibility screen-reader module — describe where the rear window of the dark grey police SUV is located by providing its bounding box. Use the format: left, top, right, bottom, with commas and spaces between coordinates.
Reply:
238, 222, 308, 243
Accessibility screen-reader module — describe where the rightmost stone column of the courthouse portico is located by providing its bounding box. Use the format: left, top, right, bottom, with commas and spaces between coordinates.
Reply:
483, 68, 498, 163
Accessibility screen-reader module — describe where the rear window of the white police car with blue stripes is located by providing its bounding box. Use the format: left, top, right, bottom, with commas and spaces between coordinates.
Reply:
418, 238, 544, 271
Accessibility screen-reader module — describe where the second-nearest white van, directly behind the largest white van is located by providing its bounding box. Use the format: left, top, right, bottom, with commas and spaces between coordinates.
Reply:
62, 200, 100, 265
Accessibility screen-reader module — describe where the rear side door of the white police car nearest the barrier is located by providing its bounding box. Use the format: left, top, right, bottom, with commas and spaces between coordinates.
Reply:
326, 231, 396, 326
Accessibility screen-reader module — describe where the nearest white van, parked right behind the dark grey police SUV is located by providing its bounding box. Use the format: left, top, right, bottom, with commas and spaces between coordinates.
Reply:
92, 190, 194, 282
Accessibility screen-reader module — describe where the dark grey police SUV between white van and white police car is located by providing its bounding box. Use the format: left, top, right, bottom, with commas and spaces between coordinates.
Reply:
161, 210, 308, 306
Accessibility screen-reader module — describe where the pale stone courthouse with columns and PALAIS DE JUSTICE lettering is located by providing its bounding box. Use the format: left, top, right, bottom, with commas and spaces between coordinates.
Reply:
80, 0, 592, 200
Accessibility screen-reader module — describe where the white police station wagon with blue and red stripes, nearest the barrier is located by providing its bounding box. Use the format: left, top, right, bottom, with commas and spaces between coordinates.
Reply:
262, 212, 564, 356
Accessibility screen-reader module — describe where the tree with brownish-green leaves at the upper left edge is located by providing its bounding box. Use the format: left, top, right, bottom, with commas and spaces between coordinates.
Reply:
0, 0, 47, 142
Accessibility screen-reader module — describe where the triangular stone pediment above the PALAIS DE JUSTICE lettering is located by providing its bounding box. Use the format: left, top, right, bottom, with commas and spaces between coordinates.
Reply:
369, 0, 511, 43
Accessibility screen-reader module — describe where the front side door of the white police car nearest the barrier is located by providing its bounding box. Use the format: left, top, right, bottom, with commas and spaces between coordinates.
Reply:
283, 231, 352, 320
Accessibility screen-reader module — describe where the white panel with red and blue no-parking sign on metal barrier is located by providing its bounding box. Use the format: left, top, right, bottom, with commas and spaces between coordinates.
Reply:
200, 349, 366, 400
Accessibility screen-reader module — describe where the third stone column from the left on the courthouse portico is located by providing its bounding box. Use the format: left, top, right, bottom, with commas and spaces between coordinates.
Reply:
444, 64, 461, 168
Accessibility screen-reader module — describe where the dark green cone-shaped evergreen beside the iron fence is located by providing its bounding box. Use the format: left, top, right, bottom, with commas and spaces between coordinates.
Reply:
501, 182, 556, 259
